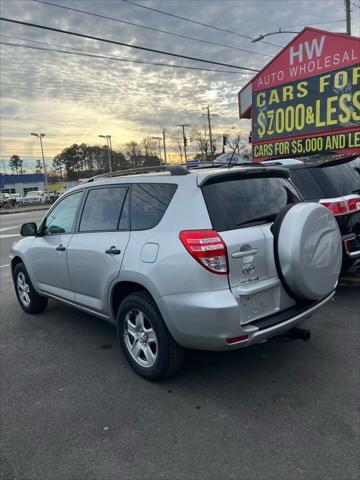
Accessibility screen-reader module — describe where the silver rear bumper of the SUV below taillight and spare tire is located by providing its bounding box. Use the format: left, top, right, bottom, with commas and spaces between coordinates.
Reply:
157, 290, 335, 351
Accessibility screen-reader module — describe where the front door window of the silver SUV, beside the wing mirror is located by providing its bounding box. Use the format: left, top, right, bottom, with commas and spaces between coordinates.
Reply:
43, 191, 83, 235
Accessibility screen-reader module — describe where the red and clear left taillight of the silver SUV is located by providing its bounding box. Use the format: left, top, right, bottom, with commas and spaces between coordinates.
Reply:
179, 230, 228, 275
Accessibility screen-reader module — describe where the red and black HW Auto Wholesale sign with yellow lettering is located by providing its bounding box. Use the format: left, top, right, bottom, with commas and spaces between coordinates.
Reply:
239, 28, 360, 161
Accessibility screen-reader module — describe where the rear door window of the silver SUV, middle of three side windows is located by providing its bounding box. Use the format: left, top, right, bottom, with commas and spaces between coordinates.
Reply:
79, 187, 128, 232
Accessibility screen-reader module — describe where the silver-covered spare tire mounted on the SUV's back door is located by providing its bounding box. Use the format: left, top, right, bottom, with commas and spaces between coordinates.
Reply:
272, 203, 342, 301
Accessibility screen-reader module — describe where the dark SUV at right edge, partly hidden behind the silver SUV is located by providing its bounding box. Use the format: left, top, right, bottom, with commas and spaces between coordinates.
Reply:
264, 156, 360, 272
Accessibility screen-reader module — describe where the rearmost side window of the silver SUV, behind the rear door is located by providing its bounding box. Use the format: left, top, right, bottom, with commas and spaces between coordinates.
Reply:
131, 183, 177, 230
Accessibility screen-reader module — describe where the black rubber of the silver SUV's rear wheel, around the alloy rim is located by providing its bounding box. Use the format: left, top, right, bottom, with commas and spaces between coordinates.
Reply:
117, 292, 184, 381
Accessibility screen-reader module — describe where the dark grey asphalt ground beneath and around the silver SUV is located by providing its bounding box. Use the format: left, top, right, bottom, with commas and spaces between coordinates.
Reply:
0, 212, 360, 480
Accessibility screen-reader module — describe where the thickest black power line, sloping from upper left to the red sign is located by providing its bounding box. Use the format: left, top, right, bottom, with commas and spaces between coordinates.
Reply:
0, 17, 259, 72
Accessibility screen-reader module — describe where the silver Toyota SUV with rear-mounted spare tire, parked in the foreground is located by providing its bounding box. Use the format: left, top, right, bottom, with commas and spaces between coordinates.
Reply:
10, 165, 342, 380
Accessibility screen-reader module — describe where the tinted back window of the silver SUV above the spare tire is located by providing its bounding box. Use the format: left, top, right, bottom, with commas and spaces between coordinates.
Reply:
203, 177, 299, 232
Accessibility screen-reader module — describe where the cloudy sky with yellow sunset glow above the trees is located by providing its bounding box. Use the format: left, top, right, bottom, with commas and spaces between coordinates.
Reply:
0, 0, 360, 171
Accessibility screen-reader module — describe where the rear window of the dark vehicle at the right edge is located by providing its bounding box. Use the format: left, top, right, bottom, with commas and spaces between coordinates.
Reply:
315, 158, 360, 197
